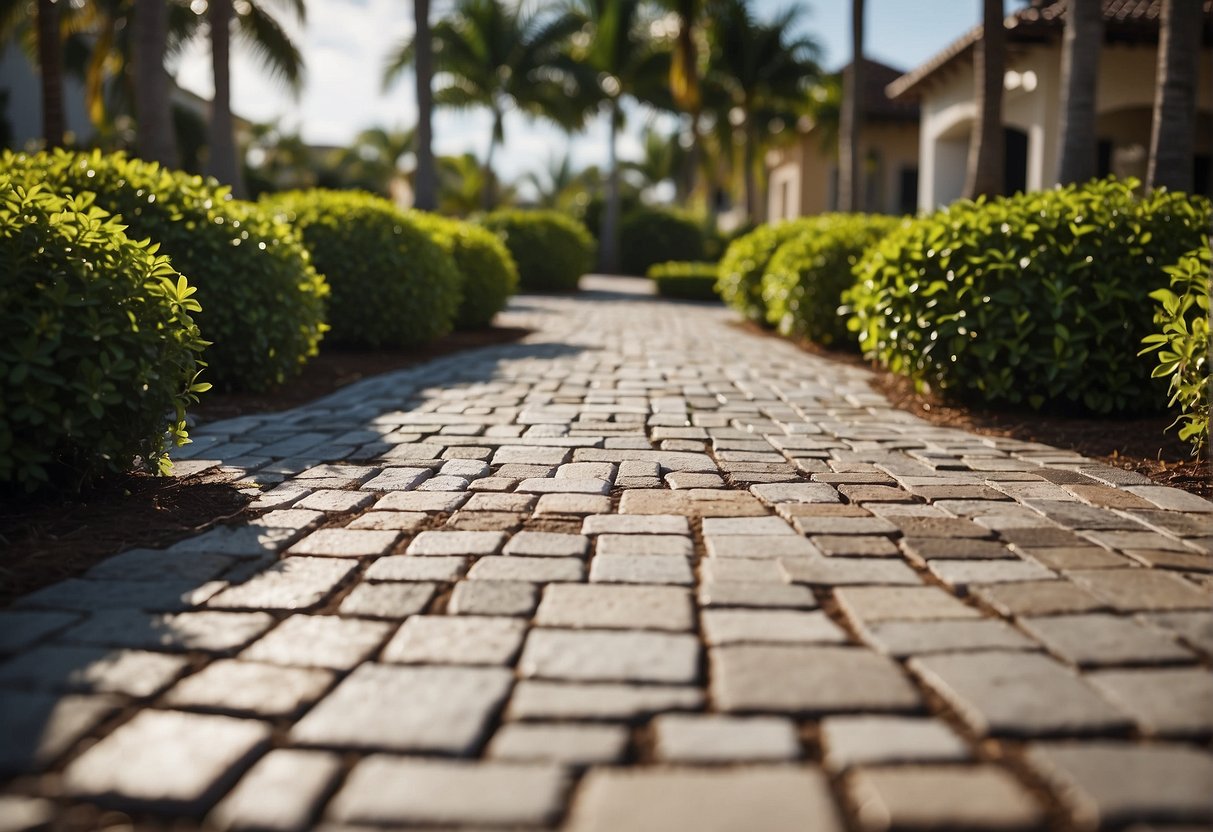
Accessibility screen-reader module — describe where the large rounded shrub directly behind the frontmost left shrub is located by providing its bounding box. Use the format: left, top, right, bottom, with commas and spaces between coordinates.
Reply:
0, 150, 328, 389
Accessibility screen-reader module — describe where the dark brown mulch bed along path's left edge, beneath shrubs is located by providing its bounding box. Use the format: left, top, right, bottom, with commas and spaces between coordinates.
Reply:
0, 327, 529, 606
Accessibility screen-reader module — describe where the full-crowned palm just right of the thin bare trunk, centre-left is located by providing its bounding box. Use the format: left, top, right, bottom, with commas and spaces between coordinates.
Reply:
383, 0, 583, 209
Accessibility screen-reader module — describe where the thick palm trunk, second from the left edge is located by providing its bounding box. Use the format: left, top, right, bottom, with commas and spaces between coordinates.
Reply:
132, 0, 177, 167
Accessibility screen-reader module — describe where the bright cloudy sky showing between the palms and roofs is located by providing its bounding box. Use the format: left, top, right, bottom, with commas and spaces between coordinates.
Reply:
176, 0, 980, 181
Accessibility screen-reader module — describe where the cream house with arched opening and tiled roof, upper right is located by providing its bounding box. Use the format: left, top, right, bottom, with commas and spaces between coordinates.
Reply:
887, 0, 1213, 210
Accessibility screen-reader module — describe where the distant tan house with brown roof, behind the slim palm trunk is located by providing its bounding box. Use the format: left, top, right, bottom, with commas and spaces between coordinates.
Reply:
767, 59, 918, 222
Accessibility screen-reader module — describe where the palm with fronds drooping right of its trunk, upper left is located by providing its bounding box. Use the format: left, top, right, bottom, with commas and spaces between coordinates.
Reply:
206, 0, 307, 196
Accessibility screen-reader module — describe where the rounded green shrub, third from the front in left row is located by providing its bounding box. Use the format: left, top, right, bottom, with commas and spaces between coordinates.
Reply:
267, 189, 462, 347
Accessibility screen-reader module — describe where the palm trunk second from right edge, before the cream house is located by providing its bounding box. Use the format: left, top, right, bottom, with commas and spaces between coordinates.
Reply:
1058, 0, 1104, 184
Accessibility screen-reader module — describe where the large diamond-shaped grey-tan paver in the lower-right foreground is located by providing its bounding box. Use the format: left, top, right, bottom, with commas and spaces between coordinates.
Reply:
910, 651, 1129, 736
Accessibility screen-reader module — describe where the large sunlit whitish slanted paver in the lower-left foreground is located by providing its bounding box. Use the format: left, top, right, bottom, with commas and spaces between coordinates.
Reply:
291, 663, 513, 756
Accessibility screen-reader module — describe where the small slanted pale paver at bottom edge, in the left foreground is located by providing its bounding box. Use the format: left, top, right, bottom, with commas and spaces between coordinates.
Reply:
207, 748, 341, 832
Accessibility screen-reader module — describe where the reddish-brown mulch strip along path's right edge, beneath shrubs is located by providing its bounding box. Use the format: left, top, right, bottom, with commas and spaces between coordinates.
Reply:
741, 324, 1213, 500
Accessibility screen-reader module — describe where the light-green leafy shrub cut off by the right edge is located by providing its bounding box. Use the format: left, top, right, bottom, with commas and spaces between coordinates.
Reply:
1141, 243, 1213, 454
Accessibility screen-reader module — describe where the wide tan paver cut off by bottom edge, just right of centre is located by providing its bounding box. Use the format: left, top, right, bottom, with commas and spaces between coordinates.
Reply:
566, 765, 843, 832
